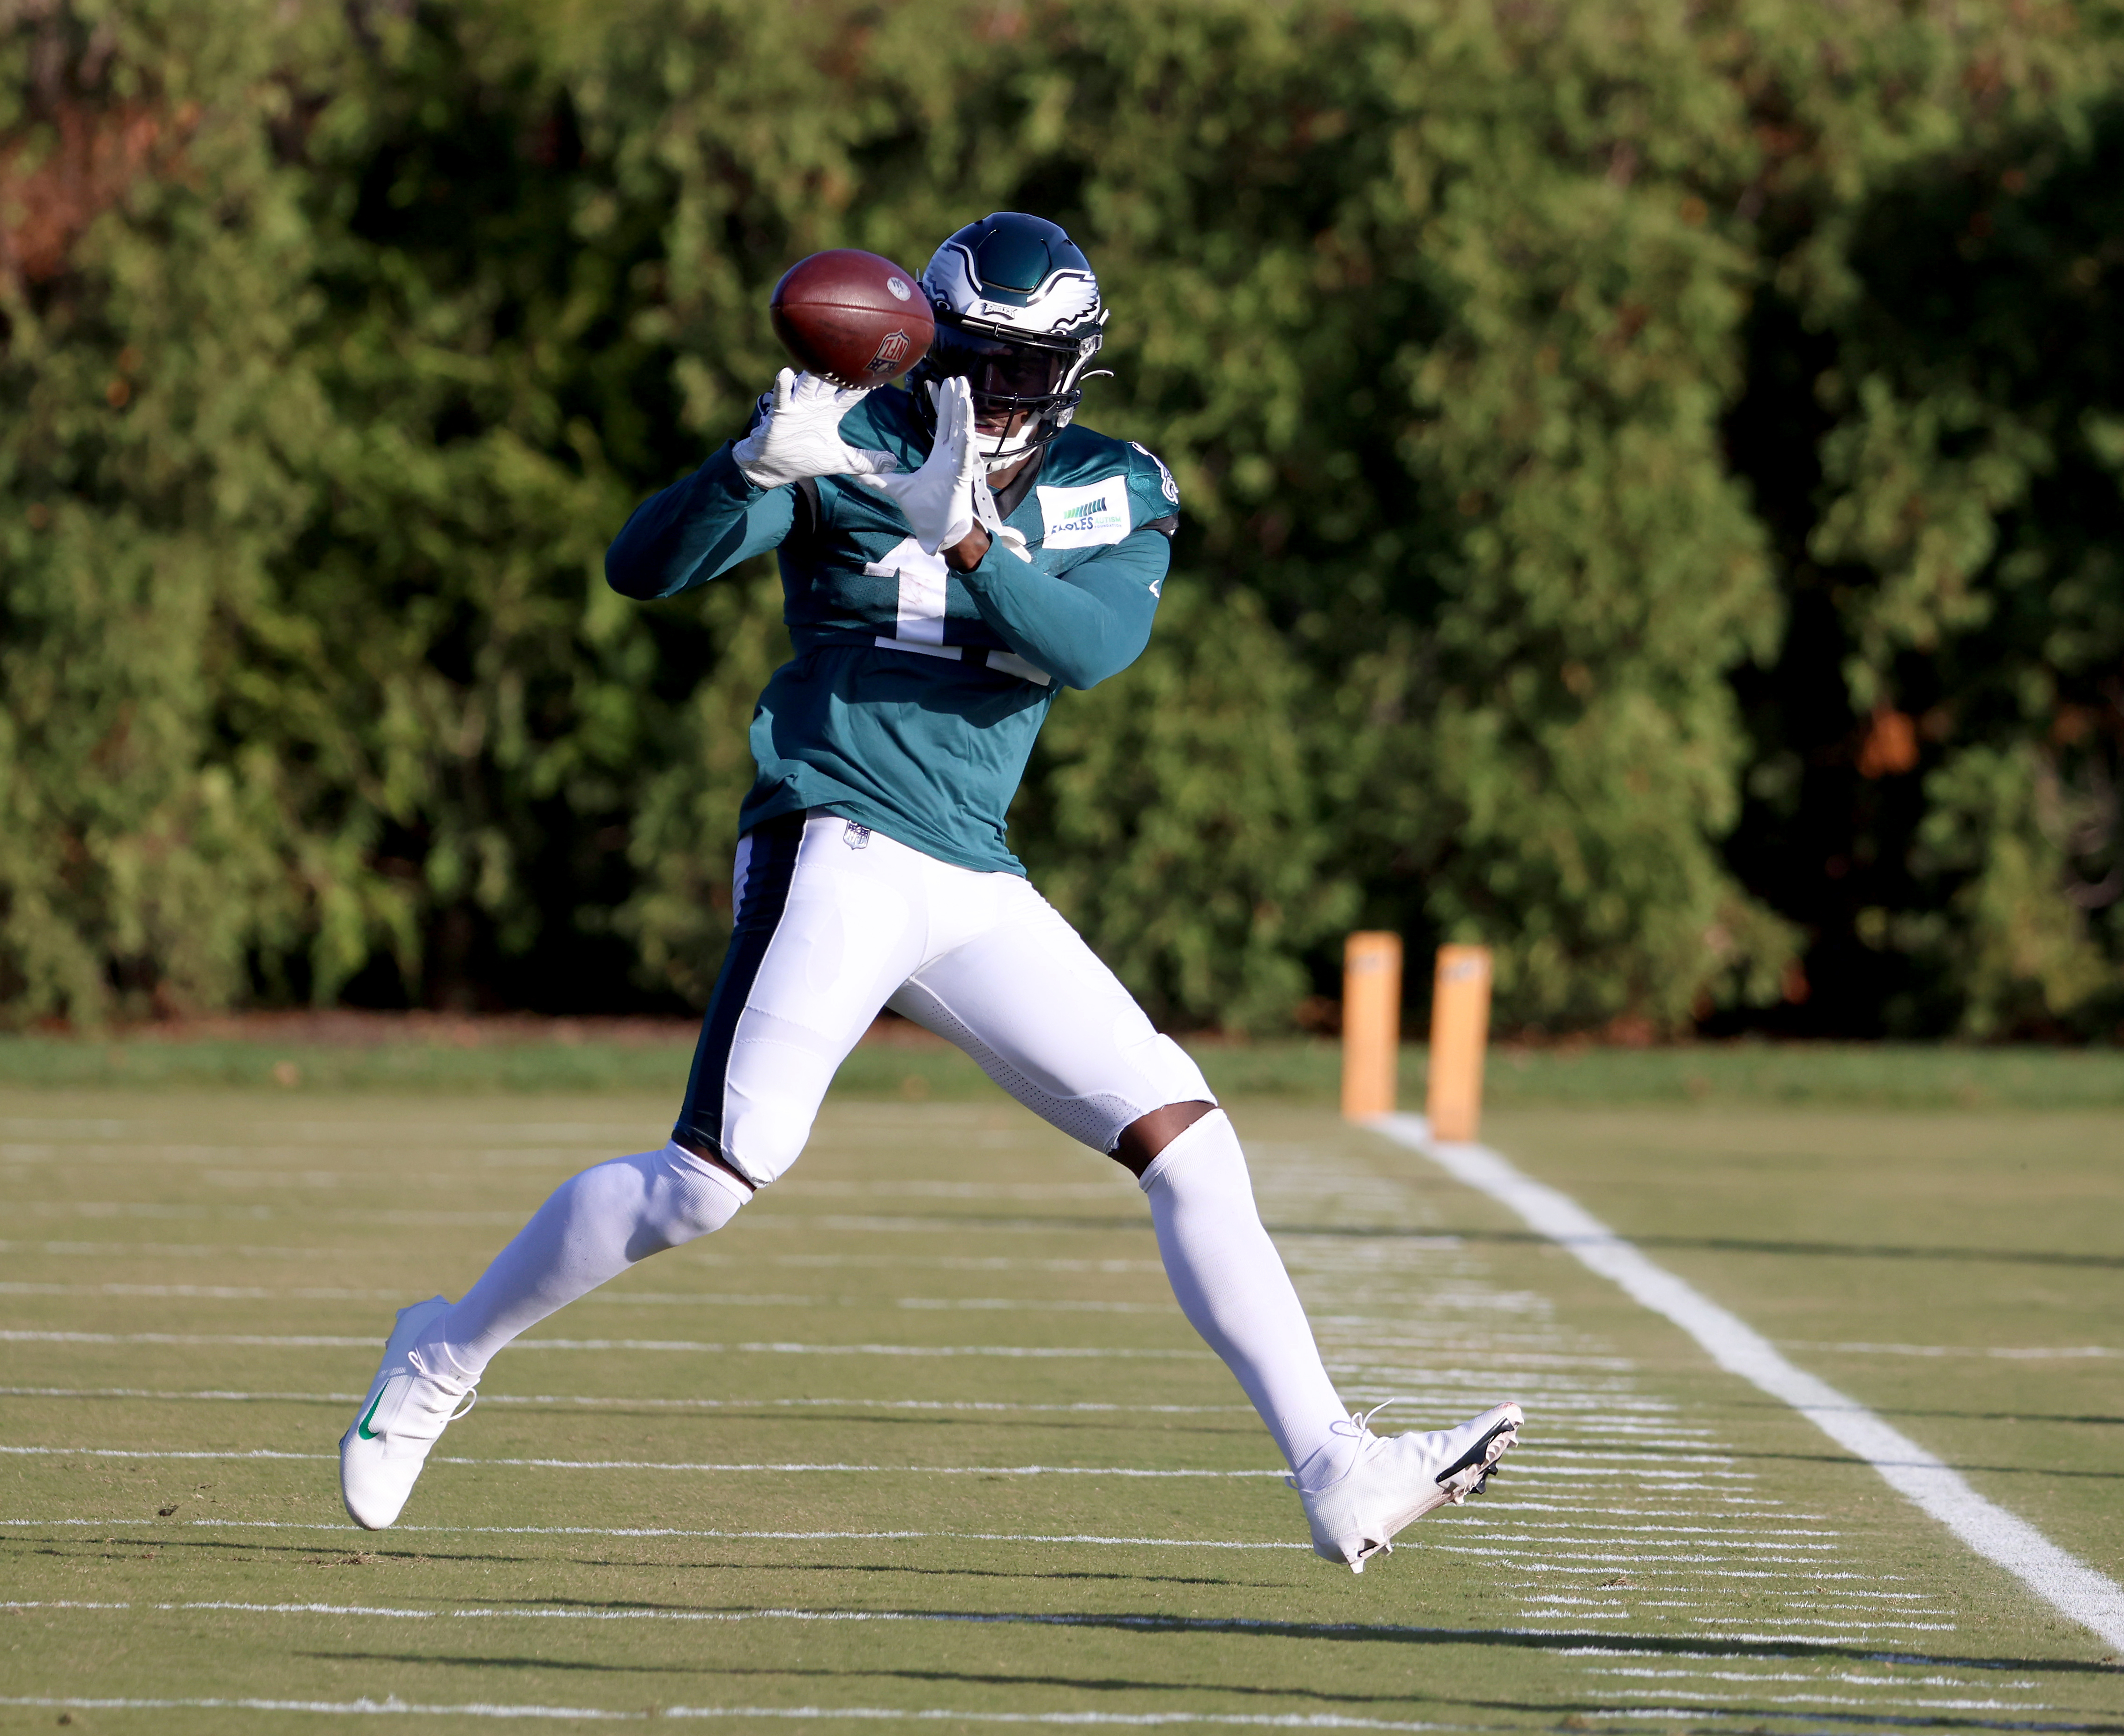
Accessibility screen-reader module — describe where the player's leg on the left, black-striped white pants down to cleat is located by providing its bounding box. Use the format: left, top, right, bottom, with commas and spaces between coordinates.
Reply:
340, 815, 922, 1528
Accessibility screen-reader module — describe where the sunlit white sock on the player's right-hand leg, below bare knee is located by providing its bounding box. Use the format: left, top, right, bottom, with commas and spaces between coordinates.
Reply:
1143, 1110, 1353, 1488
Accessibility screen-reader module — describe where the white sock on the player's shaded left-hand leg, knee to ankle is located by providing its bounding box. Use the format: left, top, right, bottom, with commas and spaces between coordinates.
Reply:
416, 1142, 752, 1380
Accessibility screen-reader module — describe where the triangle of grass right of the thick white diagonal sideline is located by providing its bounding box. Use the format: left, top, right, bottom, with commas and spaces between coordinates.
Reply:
1485, 1110, 2124, 1579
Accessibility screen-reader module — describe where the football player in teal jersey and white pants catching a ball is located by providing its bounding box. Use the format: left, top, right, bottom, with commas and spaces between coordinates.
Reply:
340, 212, 1521, 1573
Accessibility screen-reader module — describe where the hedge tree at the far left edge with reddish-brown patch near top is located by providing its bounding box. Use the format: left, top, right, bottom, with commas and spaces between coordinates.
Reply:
0, 4, 333, 1019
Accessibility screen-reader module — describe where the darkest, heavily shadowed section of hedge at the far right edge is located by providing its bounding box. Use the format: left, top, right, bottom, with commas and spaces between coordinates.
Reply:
1729, 8, 2124, 1036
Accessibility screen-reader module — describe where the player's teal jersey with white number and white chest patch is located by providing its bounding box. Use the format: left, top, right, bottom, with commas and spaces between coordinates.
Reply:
605, 386, 1179, 875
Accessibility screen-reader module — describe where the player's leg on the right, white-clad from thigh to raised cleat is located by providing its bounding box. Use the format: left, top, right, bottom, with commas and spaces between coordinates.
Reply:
892, 887, 1521, 1573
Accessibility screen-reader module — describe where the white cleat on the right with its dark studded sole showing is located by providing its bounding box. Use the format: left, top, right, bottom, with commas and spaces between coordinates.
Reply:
1285, 1399, 1523, 1573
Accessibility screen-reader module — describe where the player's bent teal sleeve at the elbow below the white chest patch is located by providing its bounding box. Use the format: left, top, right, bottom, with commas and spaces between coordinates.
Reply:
960, 524, 1172, 688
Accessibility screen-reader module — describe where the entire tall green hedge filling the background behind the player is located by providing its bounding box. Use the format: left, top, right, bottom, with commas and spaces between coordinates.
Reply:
12, 0, 2124, 1031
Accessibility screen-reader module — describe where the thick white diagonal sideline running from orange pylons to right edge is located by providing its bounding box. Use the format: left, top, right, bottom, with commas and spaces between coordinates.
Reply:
1370, 1114, 2124, 1647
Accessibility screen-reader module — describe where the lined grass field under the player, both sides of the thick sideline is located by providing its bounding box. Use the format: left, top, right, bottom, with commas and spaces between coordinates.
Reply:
0, 1080, 2124, 1732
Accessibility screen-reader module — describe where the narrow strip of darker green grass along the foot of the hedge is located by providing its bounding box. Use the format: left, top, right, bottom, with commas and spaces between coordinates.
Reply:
0, 1023, 2124, 1112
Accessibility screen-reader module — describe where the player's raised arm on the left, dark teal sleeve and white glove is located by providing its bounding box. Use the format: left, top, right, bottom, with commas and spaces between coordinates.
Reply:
605, 367, 892, 601
